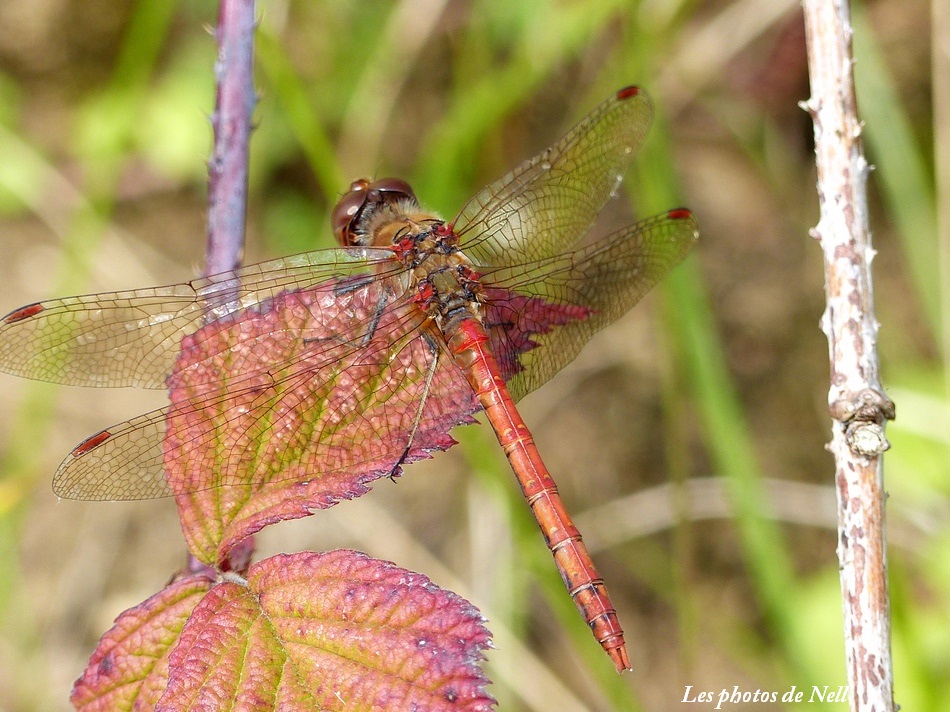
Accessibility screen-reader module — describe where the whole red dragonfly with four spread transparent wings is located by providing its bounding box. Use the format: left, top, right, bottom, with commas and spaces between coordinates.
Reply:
0, 86, 698, 672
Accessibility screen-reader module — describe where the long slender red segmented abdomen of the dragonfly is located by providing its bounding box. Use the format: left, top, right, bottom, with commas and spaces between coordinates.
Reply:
444, 317, 630, 672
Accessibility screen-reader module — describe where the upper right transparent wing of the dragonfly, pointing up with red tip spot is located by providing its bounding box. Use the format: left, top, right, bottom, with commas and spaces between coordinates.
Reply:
453, 87, 653, 266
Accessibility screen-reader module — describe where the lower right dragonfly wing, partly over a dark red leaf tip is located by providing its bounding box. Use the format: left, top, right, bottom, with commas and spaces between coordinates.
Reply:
483, 209, 699, 399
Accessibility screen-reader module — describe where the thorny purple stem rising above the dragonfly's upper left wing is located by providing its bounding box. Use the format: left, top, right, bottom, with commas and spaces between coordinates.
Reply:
205, 0, 257, 274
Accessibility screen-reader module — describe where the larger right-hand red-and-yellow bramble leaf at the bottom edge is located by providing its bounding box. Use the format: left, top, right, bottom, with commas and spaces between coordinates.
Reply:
156, 551, 494, 712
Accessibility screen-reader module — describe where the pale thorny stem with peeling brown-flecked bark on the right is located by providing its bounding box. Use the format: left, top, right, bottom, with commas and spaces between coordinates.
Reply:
803, 0, 894, 712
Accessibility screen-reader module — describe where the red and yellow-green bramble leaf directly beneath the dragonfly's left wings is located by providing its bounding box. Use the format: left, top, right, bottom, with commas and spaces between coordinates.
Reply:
164, 279, 478, 564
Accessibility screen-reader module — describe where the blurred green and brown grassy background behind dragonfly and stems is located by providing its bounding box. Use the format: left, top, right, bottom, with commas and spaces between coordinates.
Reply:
0, 0, 950, 711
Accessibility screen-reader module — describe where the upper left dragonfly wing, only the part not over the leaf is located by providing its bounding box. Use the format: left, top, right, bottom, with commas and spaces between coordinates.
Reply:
0, 248, 397, 388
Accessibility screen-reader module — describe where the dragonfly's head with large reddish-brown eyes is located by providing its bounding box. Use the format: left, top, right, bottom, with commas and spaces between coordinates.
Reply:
330, 178, 419, 247
